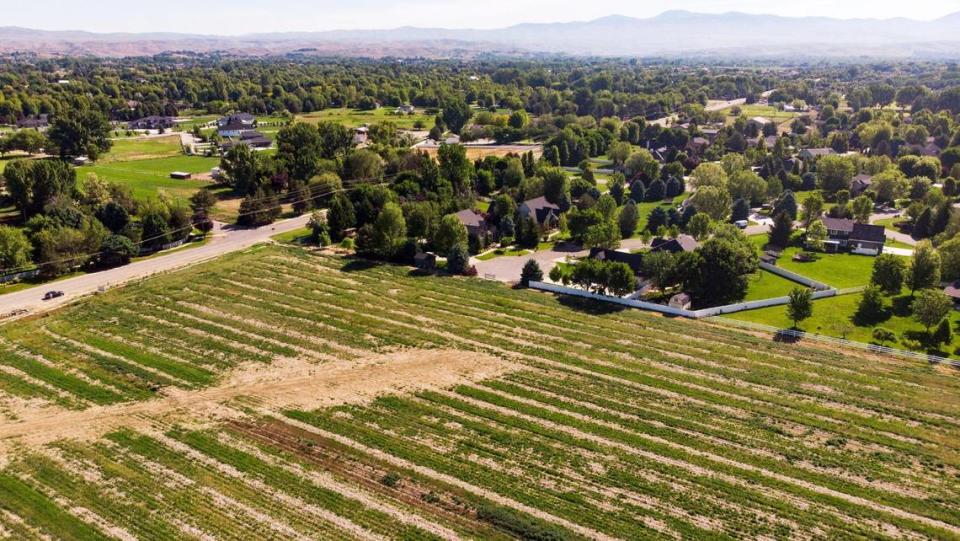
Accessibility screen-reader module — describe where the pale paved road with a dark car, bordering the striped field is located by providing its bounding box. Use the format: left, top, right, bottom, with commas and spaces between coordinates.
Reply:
0, 215, 310, 317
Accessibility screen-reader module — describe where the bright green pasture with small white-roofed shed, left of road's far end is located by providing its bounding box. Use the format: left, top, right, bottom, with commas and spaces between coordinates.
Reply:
77, 156, 220, 199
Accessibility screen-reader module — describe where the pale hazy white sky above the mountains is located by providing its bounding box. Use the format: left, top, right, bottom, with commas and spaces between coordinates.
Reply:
7, 0, 960, 35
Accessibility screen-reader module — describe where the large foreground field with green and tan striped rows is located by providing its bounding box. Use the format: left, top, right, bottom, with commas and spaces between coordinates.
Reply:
0, 246, 960, 539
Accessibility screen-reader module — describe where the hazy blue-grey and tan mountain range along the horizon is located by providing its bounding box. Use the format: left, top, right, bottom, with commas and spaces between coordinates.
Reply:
0, 11, 960, 58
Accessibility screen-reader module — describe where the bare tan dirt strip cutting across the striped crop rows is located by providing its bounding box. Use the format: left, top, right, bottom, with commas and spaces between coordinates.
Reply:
0, 350, 512, 452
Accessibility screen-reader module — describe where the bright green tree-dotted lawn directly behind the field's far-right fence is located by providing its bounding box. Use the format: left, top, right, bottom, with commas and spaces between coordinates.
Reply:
724, 288, 960, 358
